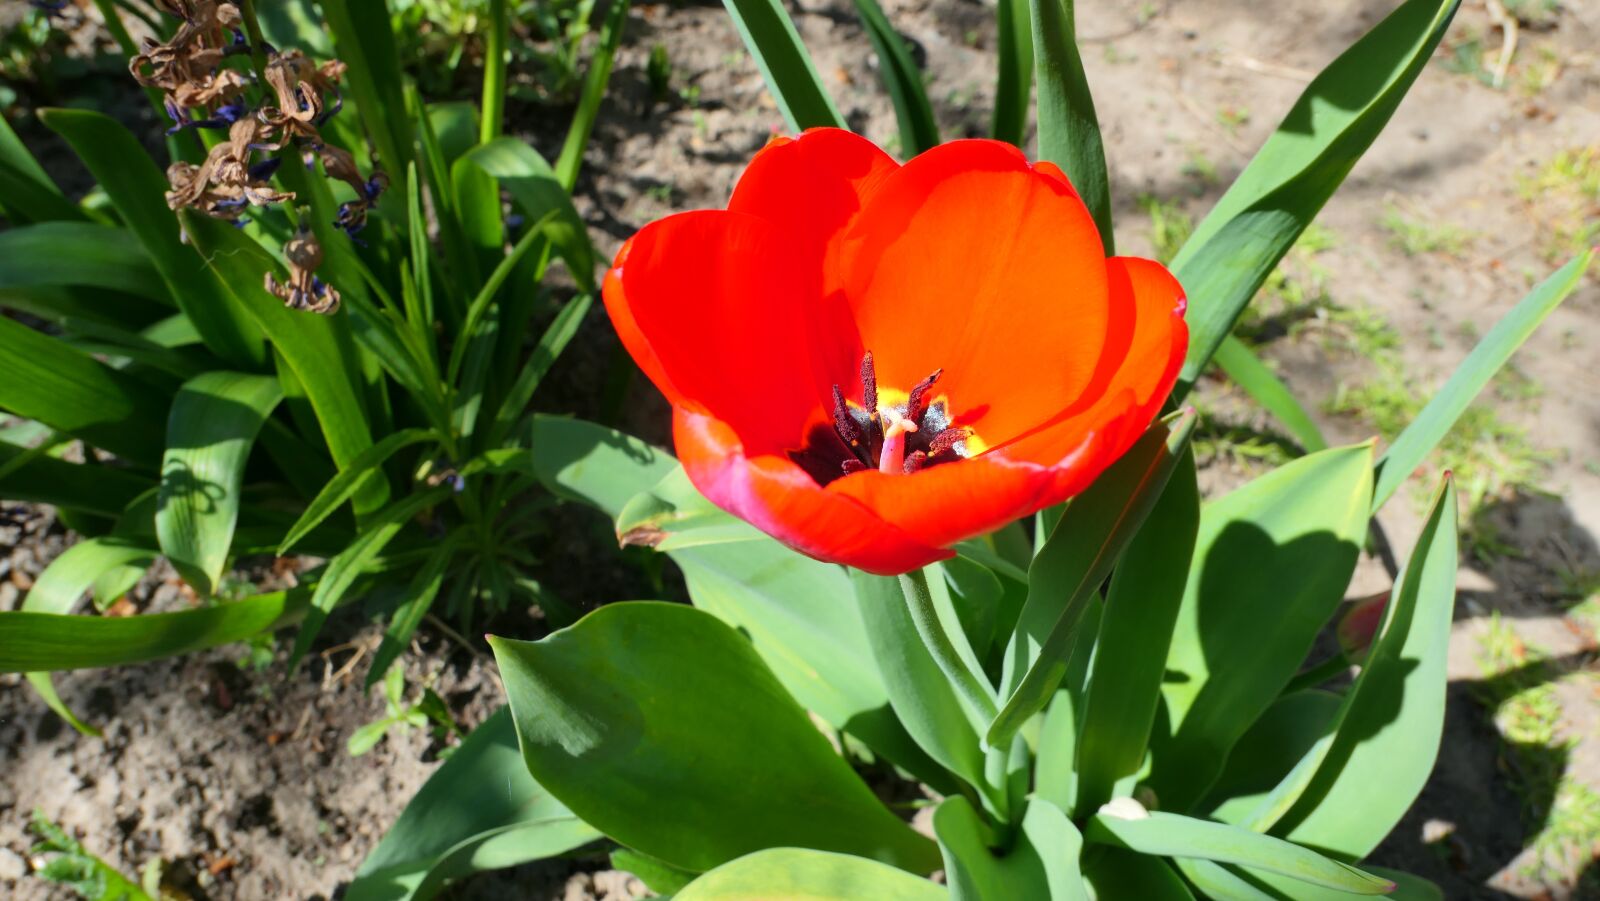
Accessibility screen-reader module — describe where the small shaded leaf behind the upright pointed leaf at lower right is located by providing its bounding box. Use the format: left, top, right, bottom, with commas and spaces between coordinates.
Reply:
1198, 688, 1344, 826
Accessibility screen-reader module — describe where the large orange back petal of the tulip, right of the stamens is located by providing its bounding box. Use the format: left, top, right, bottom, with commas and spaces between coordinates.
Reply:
840, 141, 1110, 445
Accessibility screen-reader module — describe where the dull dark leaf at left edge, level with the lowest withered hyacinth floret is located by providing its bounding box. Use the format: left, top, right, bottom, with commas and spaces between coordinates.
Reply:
0, 222, 173, 306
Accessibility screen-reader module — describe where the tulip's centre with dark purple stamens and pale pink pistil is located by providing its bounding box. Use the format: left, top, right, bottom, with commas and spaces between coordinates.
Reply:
790, 350, 973, 485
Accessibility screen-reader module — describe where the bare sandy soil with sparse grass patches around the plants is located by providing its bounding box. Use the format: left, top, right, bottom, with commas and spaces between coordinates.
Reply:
0, 0, 1600, 899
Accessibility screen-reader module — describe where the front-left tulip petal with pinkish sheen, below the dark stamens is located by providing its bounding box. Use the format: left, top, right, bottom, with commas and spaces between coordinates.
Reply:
672, 408, 952, 576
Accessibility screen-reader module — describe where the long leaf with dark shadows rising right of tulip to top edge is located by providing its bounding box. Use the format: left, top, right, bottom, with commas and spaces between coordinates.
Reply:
1171, 0, 1461, 398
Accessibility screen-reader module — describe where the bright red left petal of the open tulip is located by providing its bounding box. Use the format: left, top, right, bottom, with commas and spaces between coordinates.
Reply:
603, 210, 819, 453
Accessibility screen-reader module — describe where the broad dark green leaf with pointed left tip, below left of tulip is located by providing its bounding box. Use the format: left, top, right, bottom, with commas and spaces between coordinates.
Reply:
491, 602, 938, 872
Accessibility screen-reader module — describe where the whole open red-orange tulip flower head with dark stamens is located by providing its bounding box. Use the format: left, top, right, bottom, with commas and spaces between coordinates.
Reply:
605, 128, 1189, 575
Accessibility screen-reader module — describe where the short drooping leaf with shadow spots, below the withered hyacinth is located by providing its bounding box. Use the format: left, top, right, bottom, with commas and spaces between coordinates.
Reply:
155, 371, 283, 597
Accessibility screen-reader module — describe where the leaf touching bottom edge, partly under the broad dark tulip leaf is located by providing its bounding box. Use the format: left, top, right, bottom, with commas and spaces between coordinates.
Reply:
346, 707, 600, 901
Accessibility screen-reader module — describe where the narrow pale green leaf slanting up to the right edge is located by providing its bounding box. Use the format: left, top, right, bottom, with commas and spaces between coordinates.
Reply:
1373, 250, 1595, 512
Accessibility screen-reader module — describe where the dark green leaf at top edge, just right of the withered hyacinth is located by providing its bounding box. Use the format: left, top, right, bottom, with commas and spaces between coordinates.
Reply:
322, 0, 411, 181
